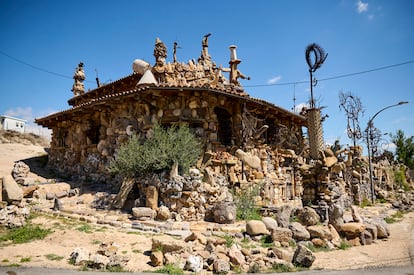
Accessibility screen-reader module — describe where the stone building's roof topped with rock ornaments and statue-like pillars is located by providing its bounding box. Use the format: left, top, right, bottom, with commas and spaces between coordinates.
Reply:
36, 34, 306, 127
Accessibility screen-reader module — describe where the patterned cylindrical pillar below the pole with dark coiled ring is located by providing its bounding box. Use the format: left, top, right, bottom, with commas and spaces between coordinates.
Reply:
307, 108, 323, 159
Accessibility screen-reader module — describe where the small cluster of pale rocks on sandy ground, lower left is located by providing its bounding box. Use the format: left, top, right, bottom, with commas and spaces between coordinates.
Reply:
70, 243, 129, 270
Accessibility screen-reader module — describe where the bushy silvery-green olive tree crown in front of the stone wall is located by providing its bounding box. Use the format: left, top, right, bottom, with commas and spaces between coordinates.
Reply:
109, 124, 202, 177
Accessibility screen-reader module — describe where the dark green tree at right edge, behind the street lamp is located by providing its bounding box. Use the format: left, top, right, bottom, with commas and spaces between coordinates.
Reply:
391, 130, 414, 169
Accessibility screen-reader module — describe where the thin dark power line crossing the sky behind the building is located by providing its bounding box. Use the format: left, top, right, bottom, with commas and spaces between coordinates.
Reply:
0, 50, 414, 88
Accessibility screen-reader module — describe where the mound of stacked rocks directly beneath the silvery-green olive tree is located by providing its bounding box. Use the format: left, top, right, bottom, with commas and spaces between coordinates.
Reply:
132, 168, 236, 223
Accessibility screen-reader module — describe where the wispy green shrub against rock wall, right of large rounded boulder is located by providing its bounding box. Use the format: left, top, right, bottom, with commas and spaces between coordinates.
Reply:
233, 184, 262, 221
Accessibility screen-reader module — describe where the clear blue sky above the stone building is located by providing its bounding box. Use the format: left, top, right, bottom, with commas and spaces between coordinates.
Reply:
0, 0, 414, 151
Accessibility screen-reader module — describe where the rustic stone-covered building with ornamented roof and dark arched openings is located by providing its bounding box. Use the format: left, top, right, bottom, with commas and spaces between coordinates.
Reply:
36, 35, 306, 206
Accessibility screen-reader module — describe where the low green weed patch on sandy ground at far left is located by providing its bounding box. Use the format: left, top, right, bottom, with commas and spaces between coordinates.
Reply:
0, 224, 53, 244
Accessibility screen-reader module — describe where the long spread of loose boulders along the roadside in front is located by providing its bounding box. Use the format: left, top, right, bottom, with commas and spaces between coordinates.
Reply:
147, 207, 389, 273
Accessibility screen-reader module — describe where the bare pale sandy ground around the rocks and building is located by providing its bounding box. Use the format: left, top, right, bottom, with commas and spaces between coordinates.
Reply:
0, 144, 414, 271
